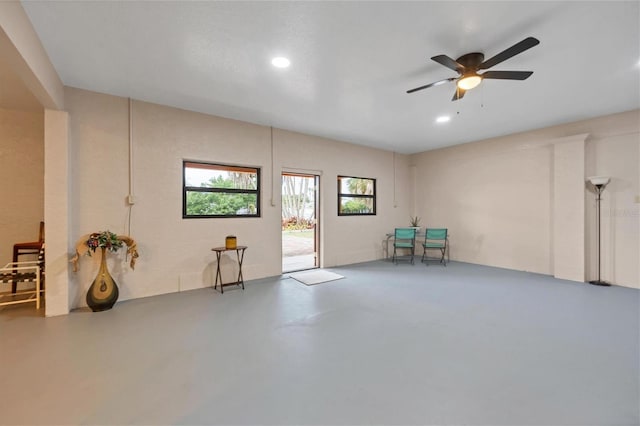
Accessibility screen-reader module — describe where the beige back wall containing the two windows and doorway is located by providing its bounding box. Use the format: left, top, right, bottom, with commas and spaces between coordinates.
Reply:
65, 88, 410, 307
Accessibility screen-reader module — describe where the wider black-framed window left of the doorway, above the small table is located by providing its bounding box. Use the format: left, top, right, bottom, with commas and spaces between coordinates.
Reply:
182, 161, 260, 218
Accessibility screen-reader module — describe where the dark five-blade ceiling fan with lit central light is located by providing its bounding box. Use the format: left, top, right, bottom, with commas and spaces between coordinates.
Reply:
407, 37, 540, 101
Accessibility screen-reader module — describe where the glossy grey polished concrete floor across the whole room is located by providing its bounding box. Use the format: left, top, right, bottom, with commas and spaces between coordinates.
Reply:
0, 261, 640, 425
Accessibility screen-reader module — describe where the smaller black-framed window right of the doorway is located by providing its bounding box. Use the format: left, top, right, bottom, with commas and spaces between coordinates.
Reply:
338, 176, 376, 216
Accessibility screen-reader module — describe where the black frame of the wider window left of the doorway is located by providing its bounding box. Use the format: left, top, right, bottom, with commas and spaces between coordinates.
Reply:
182, 160, 262, 219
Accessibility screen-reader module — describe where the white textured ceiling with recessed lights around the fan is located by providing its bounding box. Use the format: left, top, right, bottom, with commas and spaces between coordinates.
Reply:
22, 0, 640, 153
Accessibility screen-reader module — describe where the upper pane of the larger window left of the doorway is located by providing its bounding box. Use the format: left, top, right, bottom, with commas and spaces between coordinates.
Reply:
184, 163, 258, 190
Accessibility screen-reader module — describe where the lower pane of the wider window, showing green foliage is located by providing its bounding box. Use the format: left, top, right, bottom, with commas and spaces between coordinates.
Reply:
187, 191, 258, 216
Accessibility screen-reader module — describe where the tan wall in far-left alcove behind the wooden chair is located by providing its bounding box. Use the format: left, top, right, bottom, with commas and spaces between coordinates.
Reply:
0, 109, 44, 266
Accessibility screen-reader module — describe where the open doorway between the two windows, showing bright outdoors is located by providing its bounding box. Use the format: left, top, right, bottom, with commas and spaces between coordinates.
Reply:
282, 172, 320, 272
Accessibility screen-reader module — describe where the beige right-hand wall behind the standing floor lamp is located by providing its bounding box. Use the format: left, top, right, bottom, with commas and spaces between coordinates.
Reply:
411, 111, 640, 288
